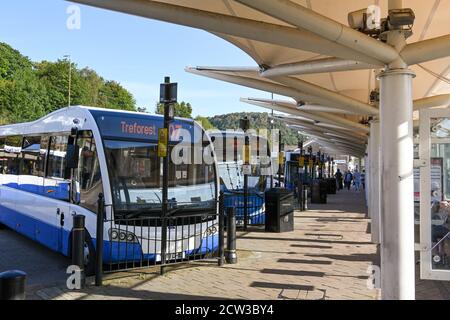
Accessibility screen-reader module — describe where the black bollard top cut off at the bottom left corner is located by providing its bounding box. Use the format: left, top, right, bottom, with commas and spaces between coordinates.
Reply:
0, 270, 27, 300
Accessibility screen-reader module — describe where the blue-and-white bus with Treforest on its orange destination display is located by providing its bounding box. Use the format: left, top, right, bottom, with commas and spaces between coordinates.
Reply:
0, 106, 219, 271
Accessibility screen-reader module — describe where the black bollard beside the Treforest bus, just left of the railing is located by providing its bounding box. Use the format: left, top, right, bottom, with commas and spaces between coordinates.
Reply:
72, 215, 86, 289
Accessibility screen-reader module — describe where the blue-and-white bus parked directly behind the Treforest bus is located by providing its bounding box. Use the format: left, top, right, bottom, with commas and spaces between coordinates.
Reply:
209, 131, 276, 225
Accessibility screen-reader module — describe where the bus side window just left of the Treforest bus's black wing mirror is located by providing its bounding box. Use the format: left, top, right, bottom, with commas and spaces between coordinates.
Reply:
44, 135, 70, 201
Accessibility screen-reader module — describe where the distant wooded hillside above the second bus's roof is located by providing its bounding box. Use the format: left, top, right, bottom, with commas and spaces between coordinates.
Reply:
208, 112, 299, 146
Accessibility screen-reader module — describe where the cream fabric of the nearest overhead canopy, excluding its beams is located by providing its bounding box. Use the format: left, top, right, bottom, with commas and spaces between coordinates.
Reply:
72, 0, 450, 103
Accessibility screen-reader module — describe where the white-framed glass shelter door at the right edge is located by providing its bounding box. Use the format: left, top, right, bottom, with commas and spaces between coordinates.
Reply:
416, 109, 450, 280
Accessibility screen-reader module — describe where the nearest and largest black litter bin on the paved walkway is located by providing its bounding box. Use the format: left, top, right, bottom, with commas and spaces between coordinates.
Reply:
265, 188, 294, 233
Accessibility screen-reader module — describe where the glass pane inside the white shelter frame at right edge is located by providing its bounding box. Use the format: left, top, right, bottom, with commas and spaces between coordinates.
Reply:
430, 118, 450, 270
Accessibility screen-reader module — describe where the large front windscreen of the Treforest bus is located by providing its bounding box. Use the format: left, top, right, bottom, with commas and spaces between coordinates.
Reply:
105, 140, 216, 216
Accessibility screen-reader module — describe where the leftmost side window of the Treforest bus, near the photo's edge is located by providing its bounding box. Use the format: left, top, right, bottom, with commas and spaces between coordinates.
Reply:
3, 136, 22, 188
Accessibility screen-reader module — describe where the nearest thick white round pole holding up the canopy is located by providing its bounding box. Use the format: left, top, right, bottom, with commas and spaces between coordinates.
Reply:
380, 63, 415, 300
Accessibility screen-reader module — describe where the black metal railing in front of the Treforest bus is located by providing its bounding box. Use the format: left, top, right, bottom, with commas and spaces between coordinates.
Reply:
96, 193, 225, 286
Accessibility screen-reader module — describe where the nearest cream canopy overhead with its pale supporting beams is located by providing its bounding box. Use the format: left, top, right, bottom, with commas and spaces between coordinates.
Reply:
70, 0, 450, 155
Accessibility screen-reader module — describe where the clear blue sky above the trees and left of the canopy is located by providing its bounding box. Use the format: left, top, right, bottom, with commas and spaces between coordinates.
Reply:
0, 0, 282, 116
